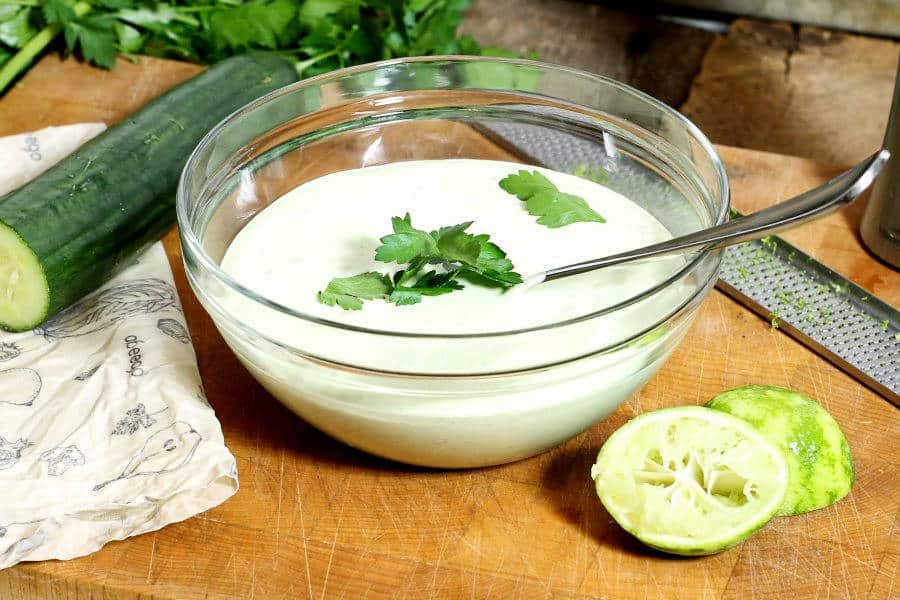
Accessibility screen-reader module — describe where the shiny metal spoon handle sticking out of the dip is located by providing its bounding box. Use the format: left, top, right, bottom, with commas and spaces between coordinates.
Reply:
526, 150, 890, 285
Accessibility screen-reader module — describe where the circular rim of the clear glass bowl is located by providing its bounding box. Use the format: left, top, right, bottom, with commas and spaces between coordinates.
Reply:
175, 54, 731, 342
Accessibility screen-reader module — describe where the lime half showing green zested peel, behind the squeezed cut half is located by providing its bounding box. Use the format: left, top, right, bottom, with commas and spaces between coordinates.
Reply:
706, 385, 854, 515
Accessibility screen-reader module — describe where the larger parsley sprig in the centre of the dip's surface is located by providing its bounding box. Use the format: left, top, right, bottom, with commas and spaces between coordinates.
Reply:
319, 213, 522, 310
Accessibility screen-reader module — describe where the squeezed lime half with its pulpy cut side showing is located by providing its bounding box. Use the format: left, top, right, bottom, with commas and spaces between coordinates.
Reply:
591, 406, 788, 556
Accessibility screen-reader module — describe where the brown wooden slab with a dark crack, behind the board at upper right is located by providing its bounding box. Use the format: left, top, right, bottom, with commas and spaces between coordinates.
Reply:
681, 19, 900, 164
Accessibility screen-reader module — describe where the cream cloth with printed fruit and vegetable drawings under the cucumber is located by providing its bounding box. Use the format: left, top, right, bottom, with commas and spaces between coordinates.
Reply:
0, 124, 238, 568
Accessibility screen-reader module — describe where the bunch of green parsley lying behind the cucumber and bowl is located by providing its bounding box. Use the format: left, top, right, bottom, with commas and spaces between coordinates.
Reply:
0, 0, 492, 93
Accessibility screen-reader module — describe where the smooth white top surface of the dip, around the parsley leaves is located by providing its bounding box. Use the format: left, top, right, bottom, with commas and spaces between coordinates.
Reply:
222, 159, 680, 334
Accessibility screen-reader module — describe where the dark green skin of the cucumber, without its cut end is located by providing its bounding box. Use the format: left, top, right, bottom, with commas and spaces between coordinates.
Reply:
0, 52, 298, 327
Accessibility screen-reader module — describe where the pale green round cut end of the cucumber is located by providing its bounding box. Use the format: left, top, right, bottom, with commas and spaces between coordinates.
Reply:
0, 222, 50, 331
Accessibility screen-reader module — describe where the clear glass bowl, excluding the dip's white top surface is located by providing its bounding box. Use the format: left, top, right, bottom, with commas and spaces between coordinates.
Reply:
177, 57, 729, 468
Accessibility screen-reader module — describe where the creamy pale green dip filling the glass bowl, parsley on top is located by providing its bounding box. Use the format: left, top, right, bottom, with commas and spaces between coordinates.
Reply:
217, 159, 698, 467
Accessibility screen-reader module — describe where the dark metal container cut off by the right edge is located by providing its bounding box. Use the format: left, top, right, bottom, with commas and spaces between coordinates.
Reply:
860, 59, 900, 268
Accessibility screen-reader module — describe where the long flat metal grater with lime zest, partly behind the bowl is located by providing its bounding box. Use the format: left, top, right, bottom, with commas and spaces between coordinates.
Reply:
477, 121, 900, 406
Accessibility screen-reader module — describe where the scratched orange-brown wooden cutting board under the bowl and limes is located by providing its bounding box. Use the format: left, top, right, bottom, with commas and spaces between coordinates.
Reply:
0, 57, 900, 600
